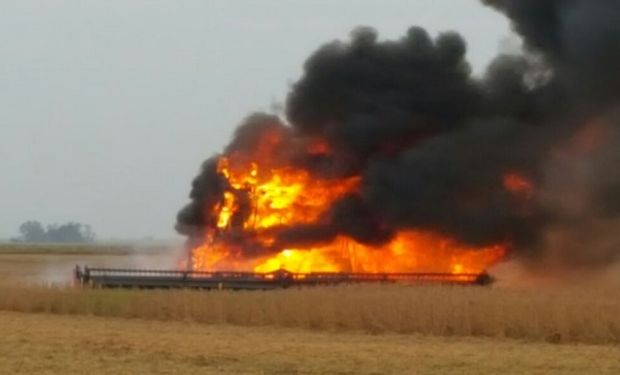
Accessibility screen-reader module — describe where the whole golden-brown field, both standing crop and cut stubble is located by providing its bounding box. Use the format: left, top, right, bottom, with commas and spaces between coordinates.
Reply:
0, 247, 620, 375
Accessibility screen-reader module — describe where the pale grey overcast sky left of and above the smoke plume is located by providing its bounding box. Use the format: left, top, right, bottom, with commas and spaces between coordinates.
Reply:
0, 0, 510, 239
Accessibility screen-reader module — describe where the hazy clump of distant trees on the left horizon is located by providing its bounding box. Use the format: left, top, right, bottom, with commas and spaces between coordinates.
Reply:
19, 221, 95, 242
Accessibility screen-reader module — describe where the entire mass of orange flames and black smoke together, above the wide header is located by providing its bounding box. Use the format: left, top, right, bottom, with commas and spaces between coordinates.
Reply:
177, 0, 620, 274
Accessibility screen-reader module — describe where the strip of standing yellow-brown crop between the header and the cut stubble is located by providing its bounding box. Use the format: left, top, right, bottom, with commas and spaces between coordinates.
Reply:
0, 285, 620, 344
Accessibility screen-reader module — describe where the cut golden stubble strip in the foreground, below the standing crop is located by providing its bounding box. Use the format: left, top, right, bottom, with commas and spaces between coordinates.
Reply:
0, 312, 620, 375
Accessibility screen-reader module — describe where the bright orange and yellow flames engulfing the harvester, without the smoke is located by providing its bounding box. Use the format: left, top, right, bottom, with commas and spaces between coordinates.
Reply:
191, 127, 508, 274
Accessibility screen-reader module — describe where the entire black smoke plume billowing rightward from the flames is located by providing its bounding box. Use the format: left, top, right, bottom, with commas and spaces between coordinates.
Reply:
177, 0, 620, 264
